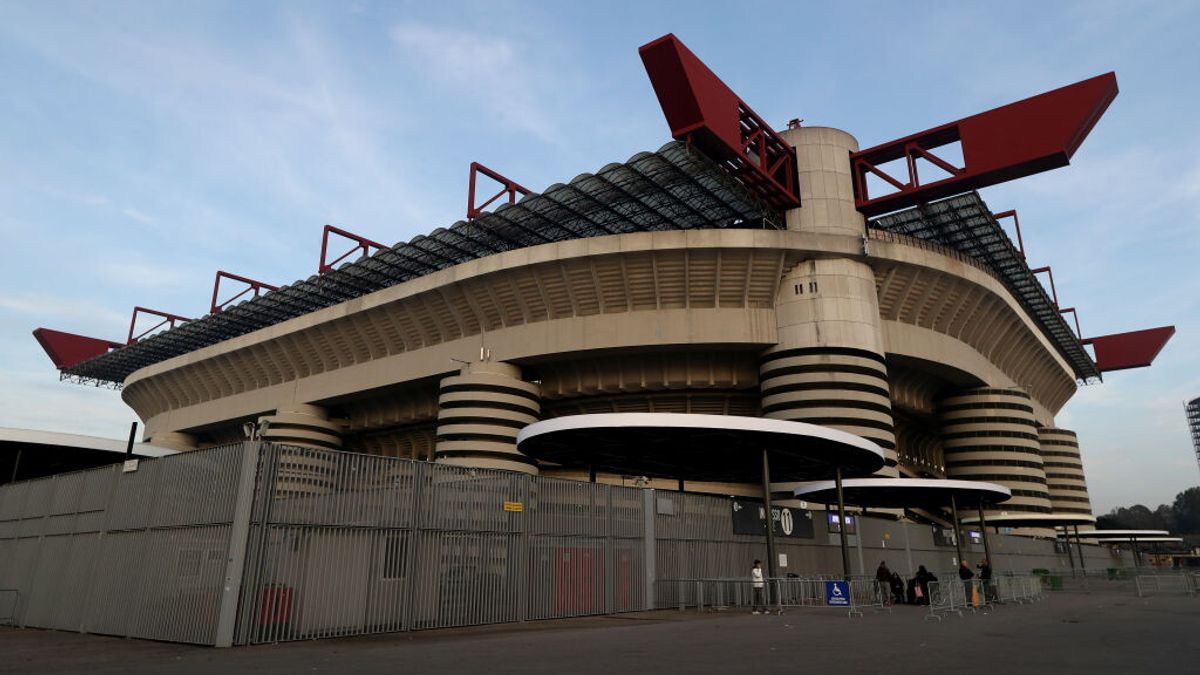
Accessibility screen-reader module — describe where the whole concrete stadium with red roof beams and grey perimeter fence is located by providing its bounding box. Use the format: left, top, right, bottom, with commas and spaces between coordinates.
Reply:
0, 35, 1174, 645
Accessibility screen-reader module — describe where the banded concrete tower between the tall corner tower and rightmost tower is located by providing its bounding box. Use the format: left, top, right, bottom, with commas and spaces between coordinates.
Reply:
937, 388, 1050, 513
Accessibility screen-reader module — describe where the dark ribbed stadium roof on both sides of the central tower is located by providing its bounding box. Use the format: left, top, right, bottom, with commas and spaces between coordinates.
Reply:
61, 142, 1100, 386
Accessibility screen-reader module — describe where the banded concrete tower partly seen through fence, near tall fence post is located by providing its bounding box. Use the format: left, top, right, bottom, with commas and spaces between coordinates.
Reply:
258, 404, 342, 497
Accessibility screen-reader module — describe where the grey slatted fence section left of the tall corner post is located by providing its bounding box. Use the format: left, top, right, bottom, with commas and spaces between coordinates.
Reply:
0, 444, 241, 644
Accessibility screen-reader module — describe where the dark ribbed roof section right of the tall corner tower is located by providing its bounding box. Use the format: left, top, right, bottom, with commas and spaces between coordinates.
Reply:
870, 192, 1100, 382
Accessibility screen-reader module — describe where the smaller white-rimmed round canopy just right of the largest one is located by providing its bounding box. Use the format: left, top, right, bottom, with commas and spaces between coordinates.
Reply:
792, 478, 1013, 508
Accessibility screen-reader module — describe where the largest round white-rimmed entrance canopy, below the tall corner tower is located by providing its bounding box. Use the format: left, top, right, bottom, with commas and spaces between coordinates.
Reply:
517, 412, 883, 482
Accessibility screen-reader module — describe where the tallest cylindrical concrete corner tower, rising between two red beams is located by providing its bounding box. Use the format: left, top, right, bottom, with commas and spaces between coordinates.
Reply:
760, 127, 899, 477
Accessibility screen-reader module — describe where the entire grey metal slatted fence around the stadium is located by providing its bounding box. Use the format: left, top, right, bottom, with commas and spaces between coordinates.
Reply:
0, 442, 1142, 646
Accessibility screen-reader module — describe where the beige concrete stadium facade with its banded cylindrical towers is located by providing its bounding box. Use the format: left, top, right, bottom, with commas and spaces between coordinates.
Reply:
122, 127, 1091, 526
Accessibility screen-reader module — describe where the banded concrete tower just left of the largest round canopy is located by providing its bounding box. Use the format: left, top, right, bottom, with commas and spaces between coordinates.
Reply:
434, 362, 541, 474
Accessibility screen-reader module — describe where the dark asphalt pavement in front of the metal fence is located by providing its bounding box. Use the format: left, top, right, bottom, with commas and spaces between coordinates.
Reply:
0, 591, 1200, 675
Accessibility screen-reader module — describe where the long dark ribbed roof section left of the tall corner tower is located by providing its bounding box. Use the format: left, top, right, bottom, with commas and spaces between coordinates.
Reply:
62, 142, 779, 384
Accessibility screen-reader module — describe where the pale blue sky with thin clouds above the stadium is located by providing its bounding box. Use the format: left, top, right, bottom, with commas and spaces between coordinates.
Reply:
0, 1, 1200, 513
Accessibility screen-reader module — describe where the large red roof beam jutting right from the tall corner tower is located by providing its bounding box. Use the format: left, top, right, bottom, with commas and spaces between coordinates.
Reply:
850, 72, 1117, 216
